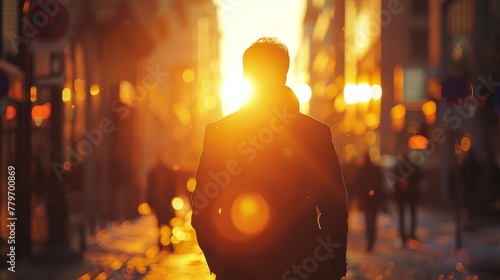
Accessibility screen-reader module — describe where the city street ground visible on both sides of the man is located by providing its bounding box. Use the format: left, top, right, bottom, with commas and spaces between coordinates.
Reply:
0, 202, 500, 280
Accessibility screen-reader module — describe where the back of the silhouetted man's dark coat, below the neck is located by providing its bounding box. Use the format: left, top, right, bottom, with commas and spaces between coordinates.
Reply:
193, 90, 347, 277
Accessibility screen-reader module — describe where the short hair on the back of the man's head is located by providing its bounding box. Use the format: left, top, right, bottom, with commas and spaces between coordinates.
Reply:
243, 37, 290, 83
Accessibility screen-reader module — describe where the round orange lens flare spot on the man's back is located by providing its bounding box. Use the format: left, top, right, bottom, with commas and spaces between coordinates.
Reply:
231, 193, 270, 235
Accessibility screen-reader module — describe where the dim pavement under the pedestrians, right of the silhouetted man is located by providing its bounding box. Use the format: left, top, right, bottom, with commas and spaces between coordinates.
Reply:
347, 201, 500, 280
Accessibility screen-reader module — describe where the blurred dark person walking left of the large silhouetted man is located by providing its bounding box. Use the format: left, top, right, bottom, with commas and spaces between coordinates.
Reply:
147, 159, 176, 252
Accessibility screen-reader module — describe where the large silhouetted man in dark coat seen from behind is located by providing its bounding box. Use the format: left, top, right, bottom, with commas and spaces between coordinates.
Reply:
192, 38, 347, 280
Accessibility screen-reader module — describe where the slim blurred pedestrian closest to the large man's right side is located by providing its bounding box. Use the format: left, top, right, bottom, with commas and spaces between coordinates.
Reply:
356, 153, 385, 252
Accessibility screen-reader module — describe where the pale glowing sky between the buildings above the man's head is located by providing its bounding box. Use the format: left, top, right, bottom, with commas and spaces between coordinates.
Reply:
215, 0, 306, 114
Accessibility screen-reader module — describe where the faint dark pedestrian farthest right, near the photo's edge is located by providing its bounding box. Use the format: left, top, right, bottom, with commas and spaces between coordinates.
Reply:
460, 150, 483, 230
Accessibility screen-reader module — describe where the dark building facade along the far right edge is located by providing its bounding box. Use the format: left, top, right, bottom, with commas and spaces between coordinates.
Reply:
432, 0, 500, 210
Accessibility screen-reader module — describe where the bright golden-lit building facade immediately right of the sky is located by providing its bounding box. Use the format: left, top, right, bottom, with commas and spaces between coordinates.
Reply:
298, 0, 383, 164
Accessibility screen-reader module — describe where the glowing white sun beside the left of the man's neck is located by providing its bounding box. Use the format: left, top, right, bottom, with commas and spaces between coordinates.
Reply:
221, 77, 252, 116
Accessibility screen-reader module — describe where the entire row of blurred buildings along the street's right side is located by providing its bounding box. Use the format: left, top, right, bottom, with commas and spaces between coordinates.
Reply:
297, 0, 500, 208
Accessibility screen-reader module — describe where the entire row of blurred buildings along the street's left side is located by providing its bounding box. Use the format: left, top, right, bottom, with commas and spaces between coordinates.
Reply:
0, 0, 221, 258
